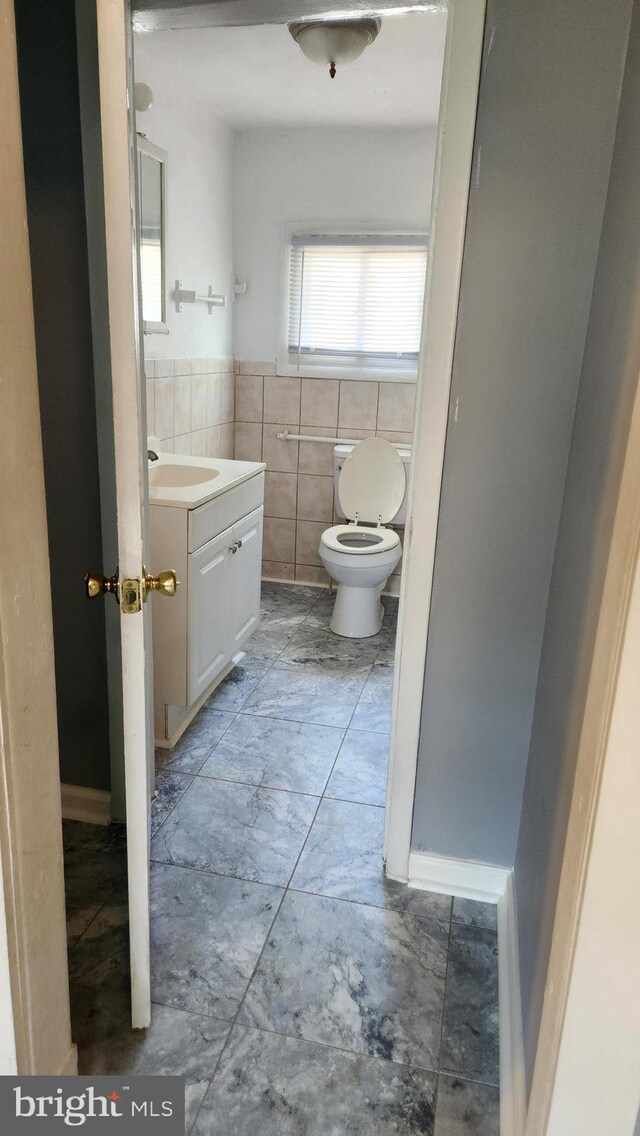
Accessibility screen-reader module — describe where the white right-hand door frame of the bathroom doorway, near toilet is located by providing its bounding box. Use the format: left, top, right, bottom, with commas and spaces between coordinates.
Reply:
384, 0, 485, 882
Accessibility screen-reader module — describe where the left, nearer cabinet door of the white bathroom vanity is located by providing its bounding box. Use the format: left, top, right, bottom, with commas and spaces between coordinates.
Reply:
188, 528, 238, 705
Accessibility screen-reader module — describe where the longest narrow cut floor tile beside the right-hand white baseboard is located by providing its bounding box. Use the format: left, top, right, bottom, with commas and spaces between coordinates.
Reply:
440, 924, 499, 1085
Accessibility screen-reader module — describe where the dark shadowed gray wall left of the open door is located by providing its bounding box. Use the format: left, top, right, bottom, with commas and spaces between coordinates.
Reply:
16, 0, 115, 788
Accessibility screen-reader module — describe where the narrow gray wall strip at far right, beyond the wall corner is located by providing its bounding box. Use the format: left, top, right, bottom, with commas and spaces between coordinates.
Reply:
515, 2, 640, 1095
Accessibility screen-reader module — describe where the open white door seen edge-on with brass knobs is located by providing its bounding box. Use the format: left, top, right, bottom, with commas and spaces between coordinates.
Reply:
92, 0, 155, 1029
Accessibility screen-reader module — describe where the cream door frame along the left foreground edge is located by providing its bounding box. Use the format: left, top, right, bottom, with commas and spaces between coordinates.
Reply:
0, 0, 77, 1076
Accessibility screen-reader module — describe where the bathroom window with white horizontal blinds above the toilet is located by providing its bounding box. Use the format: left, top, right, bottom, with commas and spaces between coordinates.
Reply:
288, 233, 426, 377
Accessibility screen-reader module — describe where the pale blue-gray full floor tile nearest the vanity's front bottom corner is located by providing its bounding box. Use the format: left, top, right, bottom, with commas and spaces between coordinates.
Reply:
200, 715, 344, 796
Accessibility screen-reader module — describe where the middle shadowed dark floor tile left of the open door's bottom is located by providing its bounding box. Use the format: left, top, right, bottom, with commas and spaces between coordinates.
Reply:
69, 884, 130, 992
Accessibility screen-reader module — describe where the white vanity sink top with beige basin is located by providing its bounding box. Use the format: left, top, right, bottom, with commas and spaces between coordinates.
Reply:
149, 453, 265, 509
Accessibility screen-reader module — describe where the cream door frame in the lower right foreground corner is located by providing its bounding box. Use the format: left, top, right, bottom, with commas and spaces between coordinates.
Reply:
525, 331, 640, 1136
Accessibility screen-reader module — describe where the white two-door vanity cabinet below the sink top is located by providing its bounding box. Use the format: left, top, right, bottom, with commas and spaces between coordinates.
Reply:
150, 467, 264, 745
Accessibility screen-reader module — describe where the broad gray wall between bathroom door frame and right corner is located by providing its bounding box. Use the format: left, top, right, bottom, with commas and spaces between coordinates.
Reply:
413, 0, 631, 866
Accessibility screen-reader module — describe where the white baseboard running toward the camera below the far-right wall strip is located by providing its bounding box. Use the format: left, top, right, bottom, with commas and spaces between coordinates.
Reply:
498, 871, 526, 1136
